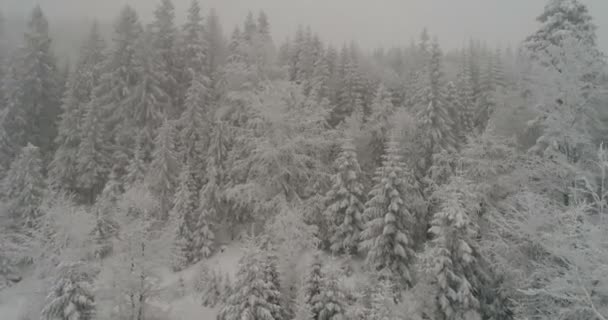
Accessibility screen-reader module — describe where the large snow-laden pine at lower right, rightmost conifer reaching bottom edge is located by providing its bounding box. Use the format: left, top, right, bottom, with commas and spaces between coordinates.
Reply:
429, 176, 481, 320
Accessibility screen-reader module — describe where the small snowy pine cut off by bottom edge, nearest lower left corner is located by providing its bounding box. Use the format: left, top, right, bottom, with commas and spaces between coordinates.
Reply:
41, 262, 95, 320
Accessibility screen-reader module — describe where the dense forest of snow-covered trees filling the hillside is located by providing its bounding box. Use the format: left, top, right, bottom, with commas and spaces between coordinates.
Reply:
0, 0, 608, 320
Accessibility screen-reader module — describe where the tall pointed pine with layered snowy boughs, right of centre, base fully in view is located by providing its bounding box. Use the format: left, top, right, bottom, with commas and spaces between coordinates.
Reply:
361, 138, 415, 290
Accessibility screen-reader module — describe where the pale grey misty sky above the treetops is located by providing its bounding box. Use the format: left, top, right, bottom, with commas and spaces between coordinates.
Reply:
0, 0, 608, 52
